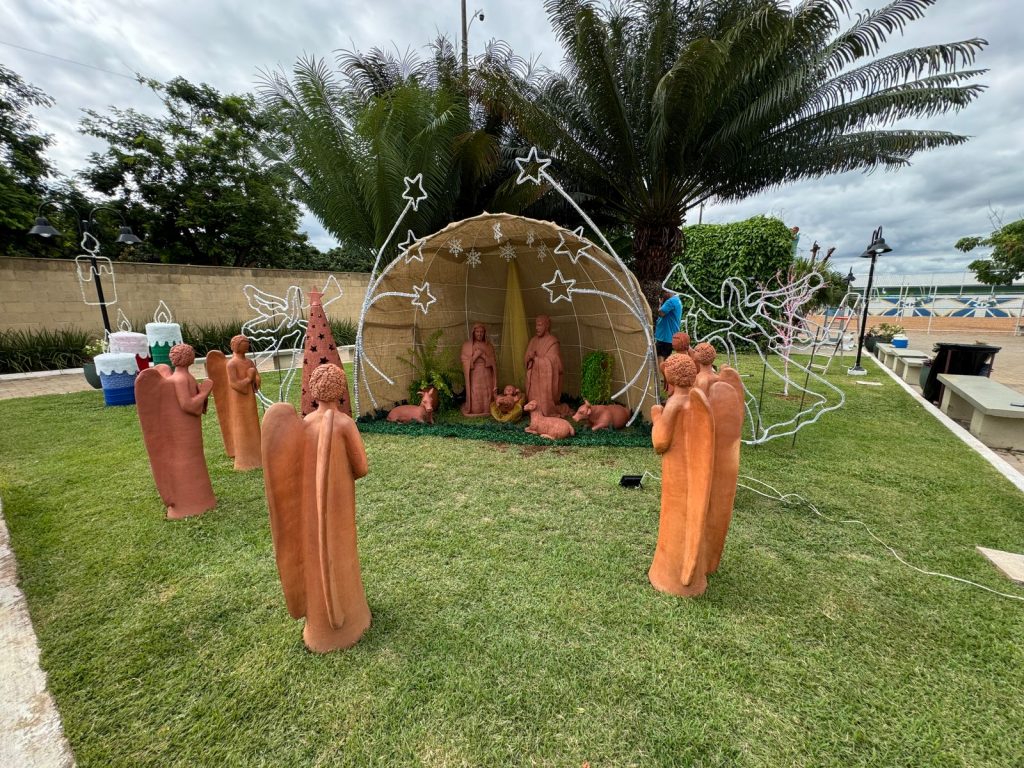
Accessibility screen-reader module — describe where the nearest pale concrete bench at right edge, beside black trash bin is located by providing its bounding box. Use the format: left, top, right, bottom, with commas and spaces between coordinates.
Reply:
939, 374, 1024, 451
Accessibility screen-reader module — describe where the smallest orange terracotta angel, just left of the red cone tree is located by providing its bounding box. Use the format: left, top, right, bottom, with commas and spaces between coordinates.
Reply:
206, 334, 262, 470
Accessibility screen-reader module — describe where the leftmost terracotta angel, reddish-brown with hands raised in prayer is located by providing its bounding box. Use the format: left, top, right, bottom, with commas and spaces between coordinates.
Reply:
135, 344, 217, 520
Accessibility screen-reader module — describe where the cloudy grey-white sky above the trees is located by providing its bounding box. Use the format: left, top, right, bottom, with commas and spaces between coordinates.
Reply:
0, 0, 1024, 274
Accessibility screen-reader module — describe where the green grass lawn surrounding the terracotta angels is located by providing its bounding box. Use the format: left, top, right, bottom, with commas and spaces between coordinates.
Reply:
0, 364, 1024, 768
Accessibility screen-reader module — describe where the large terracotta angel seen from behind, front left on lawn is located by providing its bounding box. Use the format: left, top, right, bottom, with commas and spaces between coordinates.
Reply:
263, 364, 371, 653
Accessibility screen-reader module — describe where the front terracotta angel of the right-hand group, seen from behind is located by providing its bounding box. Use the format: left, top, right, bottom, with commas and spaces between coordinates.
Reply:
648, 354, 743, 597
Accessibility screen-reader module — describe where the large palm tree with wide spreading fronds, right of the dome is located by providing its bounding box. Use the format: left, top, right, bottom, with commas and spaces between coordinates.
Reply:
496, 0, 986, 307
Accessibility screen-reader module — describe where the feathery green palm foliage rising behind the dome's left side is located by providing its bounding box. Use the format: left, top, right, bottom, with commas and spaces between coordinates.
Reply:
262, 38, 539, 263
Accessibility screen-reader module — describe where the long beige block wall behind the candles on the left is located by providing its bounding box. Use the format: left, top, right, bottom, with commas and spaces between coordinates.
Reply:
0, 257, 370, 333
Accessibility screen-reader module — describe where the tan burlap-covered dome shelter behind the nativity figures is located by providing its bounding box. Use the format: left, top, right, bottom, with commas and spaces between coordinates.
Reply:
354, 213, 659, 416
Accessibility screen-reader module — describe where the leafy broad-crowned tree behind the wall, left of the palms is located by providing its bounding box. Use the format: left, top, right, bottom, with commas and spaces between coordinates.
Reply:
81, 78, 318, 266
